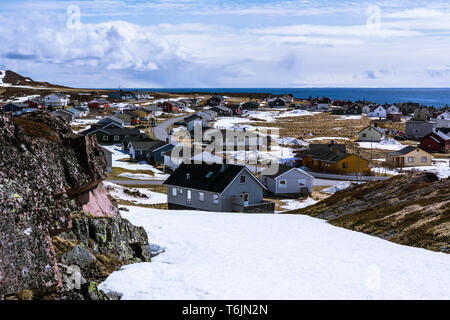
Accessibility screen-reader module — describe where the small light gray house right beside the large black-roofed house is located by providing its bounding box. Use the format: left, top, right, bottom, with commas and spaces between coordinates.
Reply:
261, 166, 314, 196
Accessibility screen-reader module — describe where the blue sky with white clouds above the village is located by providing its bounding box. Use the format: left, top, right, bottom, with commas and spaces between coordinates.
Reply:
0, 0, 450, 88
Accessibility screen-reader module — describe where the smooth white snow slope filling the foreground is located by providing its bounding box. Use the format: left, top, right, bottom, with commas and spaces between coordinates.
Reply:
100, 207, 450, 299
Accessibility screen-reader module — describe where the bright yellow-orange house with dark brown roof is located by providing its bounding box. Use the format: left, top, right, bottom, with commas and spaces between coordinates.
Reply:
298, 142, 370, 175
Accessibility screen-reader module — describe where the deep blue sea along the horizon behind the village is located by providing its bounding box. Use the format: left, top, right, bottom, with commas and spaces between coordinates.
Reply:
118, 88, 450, 108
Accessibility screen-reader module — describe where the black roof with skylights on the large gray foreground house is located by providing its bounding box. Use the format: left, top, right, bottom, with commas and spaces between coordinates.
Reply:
164, 163, 259, 193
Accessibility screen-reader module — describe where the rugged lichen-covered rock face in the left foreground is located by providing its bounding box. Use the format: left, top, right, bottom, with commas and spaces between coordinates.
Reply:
0, 112, 149, 298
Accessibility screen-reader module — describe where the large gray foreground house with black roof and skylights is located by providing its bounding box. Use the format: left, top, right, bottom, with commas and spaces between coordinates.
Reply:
164, 163, 275, 213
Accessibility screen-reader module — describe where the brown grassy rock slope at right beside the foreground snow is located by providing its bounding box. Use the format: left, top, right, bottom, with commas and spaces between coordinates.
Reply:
289, 172, 450, 253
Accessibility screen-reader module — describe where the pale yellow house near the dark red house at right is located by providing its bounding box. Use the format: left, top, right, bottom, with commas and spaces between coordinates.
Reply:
386, 146, 432, 167
